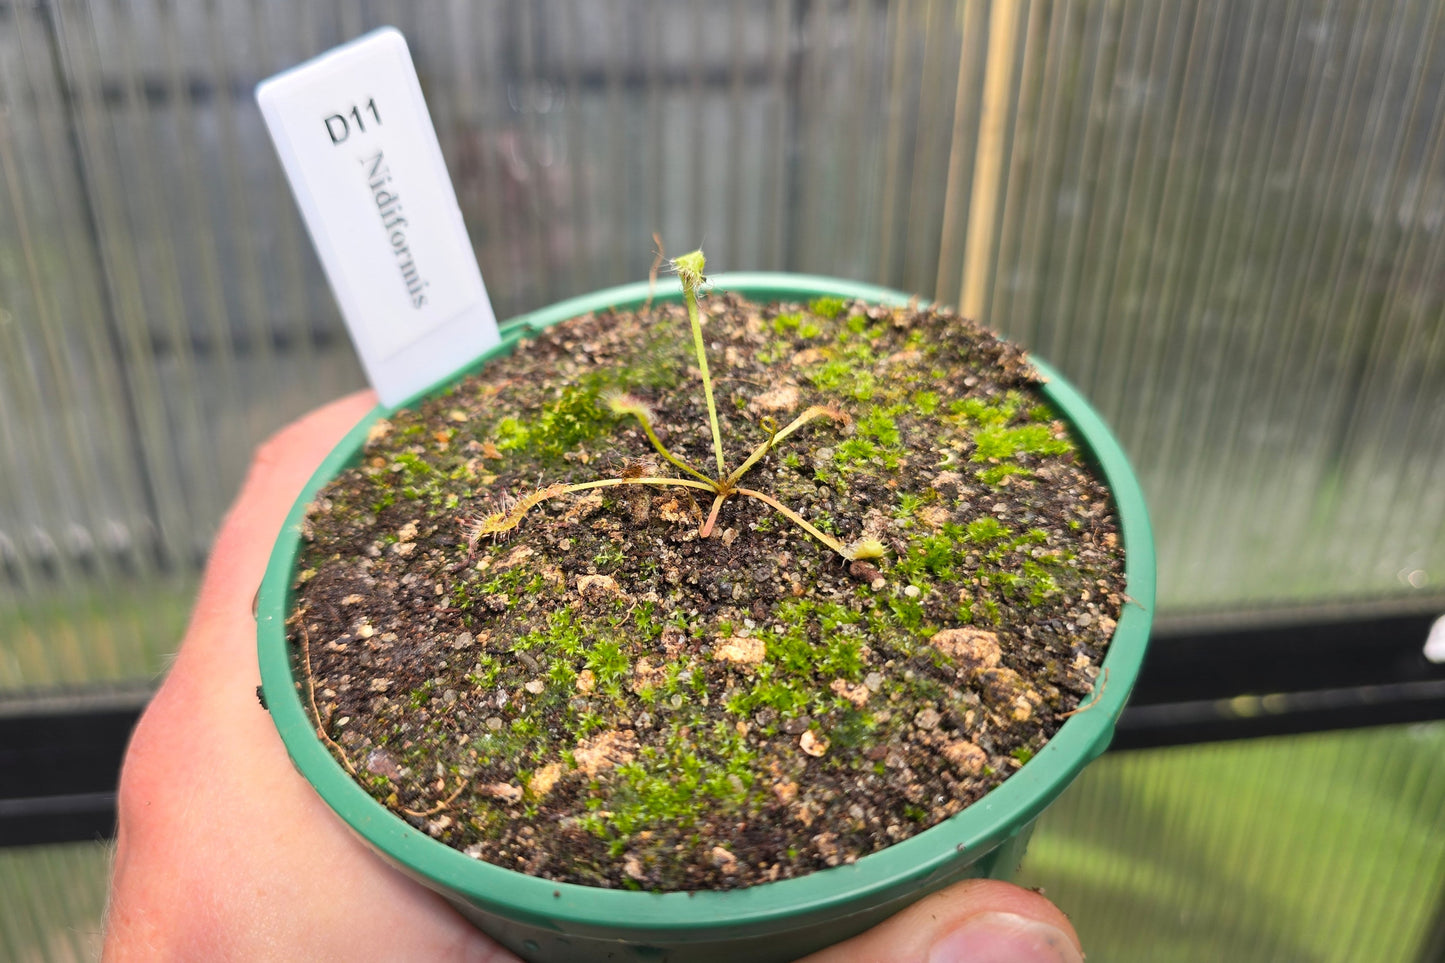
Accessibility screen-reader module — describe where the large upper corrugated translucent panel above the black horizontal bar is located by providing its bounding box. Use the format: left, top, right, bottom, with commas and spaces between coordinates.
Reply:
0, 0, 1445, 630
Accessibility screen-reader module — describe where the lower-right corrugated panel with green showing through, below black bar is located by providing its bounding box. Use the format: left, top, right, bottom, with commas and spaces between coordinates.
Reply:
1020, 723, 1445, 963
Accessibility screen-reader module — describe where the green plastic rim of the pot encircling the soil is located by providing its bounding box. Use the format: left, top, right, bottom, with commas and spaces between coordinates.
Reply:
256, 272, 1155, 936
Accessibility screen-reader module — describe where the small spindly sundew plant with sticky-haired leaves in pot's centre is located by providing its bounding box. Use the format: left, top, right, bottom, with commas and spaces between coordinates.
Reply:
468, 249, 886, 561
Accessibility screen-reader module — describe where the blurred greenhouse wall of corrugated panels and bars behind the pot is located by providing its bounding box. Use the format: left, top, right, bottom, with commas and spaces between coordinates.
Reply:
0, 0, 1445, 963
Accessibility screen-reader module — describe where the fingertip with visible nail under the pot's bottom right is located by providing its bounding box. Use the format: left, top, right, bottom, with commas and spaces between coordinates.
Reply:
805, 879, 1084, 963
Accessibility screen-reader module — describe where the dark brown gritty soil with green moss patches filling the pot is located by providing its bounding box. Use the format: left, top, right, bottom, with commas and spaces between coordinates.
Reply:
292, 295, 1123, 889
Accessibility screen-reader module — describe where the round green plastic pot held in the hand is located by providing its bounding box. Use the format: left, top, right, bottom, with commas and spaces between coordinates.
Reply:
257, 273, 1155, 963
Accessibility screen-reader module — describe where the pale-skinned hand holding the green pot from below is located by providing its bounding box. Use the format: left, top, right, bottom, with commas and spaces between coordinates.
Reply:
103, 392, 1082, 963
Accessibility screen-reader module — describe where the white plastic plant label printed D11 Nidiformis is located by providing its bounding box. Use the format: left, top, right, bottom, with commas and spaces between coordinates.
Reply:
256, 27, 499, 405
